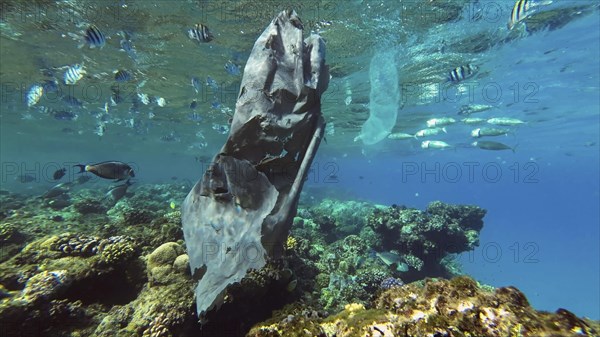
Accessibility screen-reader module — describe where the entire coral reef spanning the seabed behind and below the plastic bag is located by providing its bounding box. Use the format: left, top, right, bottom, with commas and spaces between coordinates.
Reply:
0, 189, 598, 337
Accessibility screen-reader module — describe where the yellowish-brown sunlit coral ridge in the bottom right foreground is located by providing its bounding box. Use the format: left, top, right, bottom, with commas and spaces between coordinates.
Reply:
247, 277, 598, 337
